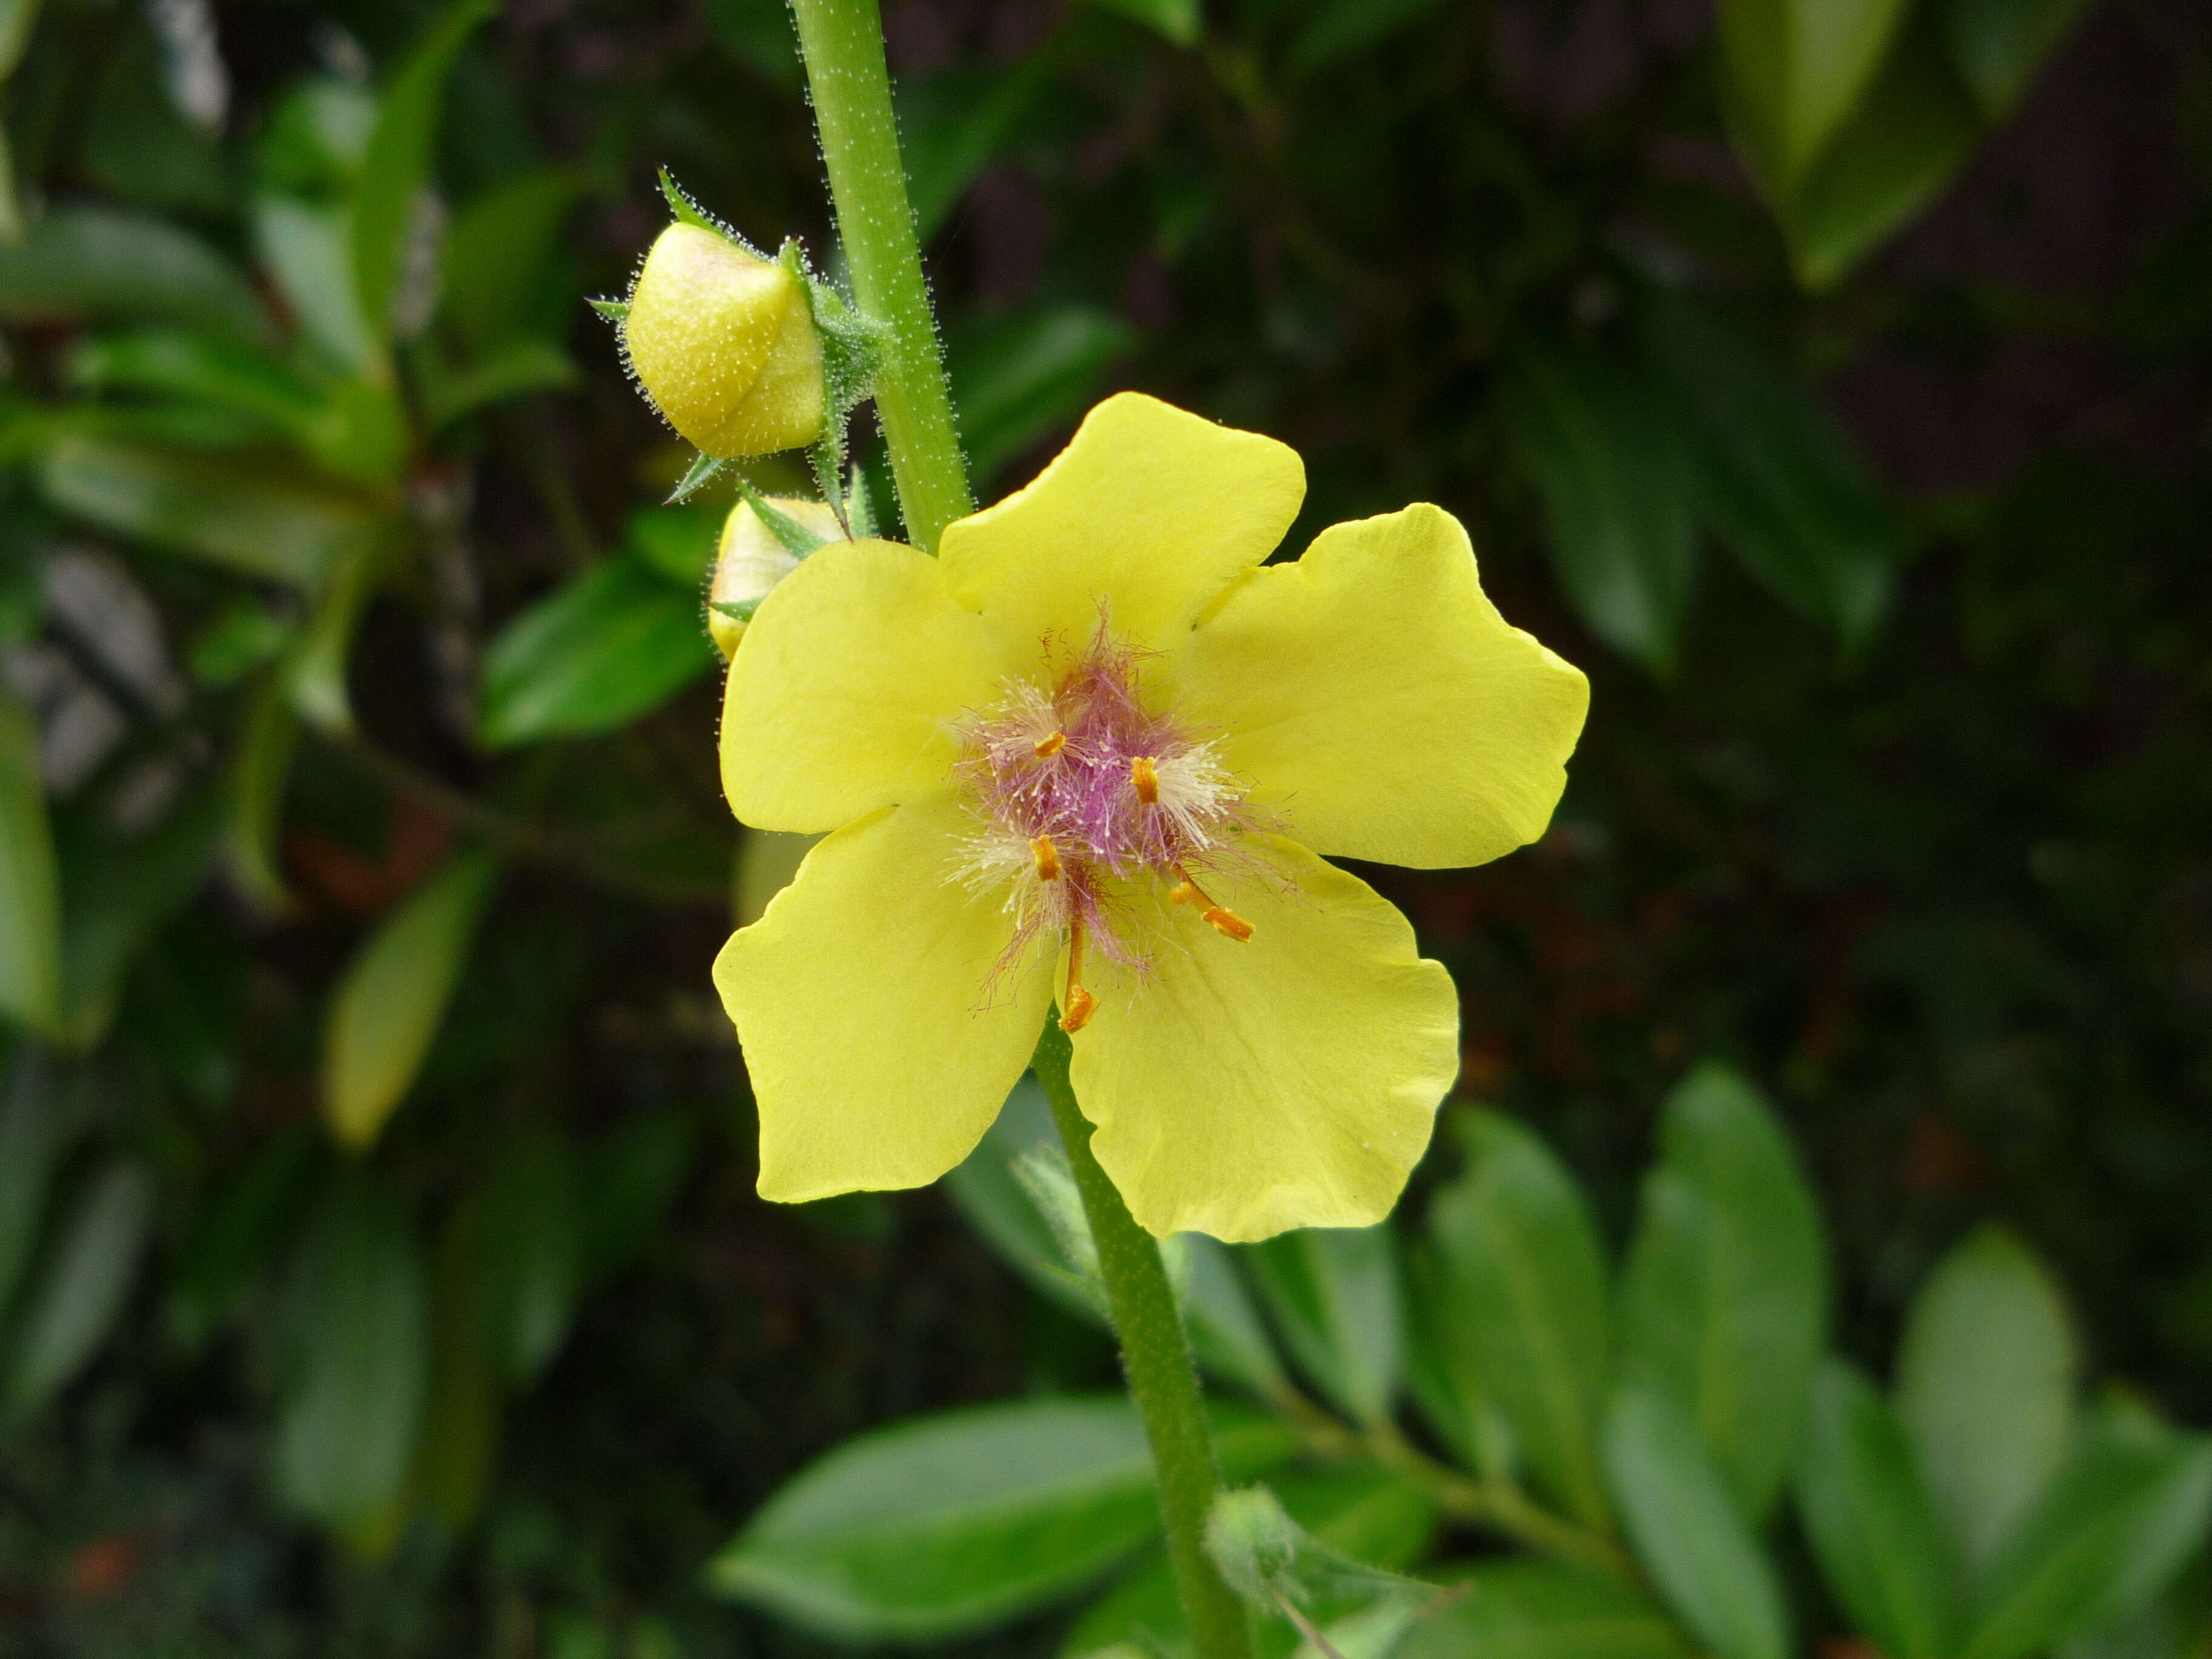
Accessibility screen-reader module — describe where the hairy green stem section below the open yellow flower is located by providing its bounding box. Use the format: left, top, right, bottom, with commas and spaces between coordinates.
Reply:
1031, 1020, 1252, 1659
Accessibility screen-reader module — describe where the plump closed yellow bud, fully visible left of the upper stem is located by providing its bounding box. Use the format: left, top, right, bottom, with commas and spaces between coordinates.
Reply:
622, 223, 827, 455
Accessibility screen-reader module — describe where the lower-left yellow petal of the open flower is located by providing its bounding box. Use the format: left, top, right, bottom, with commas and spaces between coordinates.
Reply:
714, 792, 1051, 1204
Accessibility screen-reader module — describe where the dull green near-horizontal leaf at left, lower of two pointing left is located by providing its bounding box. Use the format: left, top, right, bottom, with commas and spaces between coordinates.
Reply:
38, 434, 389, 588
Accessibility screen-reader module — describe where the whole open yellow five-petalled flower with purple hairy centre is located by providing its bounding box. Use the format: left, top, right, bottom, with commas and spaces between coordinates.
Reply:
714, 394, 1588, 1241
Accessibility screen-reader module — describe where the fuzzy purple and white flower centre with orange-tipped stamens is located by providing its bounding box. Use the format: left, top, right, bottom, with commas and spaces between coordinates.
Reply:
953, 622, 1259, 1031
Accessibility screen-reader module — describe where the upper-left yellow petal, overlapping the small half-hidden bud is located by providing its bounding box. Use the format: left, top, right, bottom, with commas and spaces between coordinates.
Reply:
721, 542, 1000, 834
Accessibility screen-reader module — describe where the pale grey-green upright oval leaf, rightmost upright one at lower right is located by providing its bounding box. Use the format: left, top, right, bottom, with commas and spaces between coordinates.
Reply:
1898, 1225, 2077, 1570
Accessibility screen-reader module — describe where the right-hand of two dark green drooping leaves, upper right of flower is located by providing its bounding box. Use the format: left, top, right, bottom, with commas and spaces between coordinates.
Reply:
1643, 292, 1905, 646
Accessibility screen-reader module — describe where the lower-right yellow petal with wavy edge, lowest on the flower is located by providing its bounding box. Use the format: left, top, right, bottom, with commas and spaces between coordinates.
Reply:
1071, 836, 1460, 1243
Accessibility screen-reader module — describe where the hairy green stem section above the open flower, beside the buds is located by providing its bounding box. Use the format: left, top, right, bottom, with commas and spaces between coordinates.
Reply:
792, 0, 976, 553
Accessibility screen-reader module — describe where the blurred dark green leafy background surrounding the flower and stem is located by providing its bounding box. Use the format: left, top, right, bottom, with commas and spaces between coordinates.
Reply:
0, 0, 2212, 1659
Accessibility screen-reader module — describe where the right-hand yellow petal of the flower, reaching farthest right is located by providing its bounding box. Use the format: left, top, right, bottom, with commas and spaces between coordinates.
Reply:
1170, 504, 1590, 870
